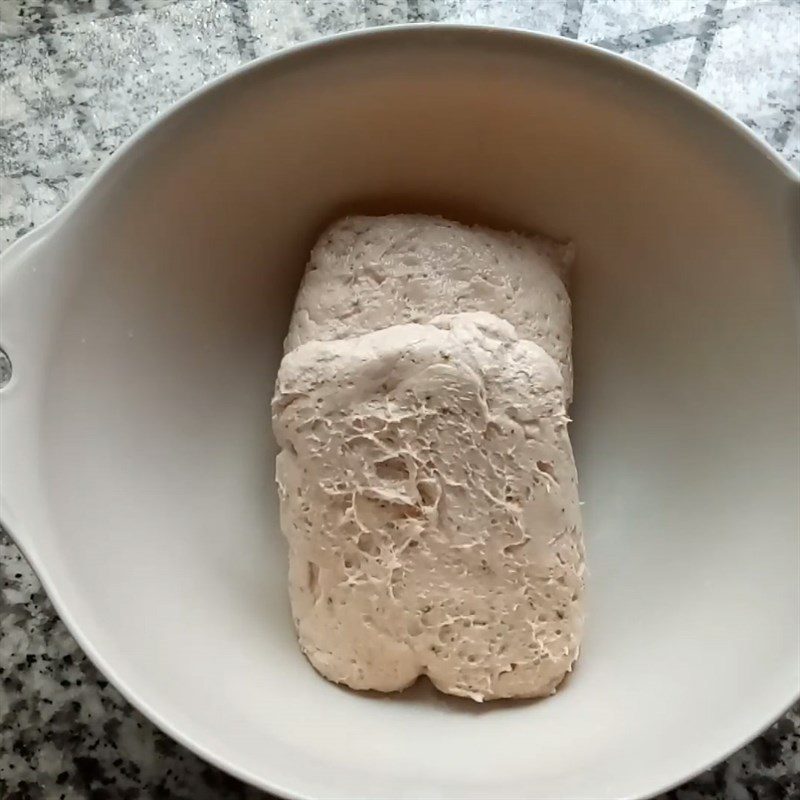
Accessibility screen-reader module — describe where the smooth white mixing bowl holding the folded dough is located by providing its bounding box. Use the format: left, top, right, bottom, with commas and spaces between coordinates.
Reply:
0, 27, 800, 800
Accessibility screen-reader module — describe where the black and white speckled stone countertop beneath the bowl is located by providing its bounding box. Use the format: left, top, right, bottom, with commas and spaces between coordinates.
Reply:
0, 0, 800, 800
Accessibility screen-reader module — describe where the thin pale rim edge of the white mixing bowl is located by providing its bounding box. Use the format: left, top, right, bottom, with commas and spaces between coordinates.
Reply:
0, 22, 800, 800
